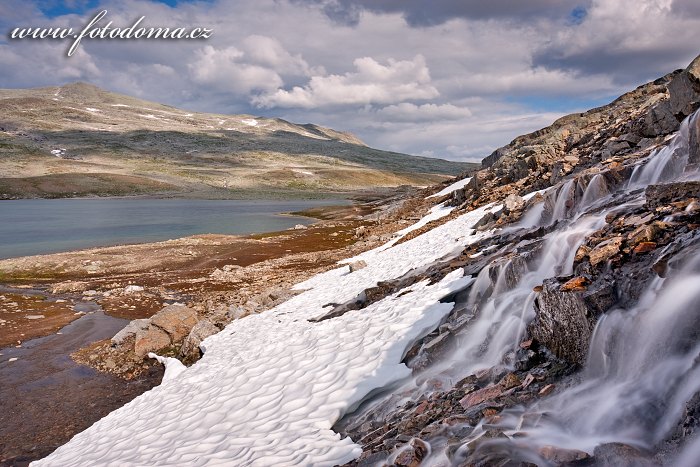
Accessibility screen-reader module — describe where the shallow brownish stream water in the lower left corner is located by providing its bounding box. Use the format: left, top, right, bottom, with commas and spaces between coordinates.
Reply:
0, 287, 162, 466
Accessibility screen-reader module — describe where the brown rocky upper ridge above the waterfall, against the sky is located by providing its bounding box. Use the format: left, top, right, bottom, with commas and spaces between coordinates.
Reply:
462, 57, 700, 211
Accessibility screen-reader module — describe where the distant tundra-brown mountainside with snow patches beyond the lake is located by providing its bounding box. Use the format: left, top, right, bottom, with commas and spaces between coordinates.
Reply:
0, 83, 471, 199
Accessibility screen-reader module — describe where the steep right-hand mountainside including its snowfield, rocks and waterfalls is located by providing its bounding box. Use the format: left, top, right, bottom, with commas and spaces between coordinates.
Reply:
27, 57, 700, 467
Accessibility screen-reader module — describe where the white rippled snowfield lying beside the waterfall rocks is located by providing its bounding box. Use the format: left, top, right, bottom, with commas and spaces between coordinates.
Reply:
32, 202, 500, 466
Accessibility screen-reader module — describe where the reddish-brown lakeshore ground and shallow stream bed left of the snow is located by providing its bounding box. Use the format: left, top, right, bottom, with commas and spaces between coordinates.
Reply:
0, 187, 432, 465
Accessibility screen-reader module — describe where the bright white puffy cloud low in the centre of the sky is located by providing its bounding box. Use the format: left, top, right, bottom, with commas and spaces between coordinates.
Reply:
253, 55, 440, 108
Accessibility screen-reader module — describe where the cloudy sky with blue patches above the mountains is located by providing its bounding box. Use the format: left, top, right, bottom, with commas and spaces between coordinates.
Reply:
0, 0, 700, 160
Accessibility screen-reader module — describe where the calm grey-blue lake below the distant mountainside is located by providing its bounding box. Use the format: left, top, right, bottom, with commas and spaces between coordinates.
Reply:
0, 198, 347, 259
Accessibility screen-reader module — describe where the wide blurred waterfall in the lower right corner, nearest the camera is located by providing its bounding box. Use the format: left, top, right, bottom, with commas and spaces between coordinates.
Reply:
457, 247, 700, 465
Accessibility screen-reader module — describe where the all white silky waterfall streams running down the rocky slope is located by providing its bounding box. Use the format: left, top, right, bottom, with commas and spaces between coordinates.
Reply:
340, 112, 700, 467
